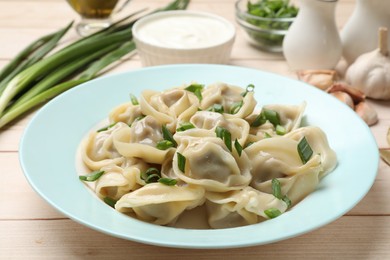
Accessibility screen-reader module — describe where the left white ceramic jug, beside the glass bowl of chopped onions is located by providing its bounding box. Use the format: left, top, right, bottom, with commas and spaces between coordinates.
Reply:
283, 0, 342, 70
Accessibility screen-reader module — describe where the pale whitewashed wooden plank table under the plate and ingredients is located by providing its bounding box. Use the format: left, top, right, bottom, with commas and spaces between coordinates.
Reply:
0, 0, 390, 259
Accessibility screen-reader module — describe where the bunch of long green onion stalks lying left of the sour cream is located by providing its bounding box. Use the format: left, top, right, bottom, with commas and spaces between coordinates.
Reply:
0, 0, 190, 128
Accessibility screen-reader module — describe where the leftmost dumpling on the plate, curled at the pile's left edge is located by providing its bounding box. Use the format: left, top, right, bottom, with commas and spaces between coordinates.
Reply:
81, 122, 129, 170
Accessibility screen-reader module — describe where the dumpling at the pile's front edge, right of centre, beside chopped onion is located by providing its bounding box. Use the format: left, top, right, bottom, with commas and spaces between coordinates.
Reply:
206, 187, 287, 228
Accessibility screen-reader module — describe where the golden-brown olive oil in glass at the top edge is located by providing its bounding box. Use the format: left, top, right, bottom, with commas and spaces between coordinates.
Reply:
67, 0, 118, 19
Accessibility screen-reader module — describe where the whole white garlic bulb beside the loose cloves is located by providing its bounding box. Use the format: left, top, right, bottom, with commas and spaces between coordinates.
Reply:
345, 49, 390, 100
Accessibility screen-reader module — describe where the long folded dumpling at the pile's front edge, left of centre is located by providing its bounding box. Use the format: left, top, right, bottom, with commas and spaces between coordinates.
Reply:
115, 183, 205, 225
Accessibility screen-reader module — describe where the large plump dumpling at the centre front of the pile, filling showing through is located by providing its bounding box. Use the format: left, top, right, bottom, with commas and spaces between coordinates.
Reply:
172, 137, 251, 192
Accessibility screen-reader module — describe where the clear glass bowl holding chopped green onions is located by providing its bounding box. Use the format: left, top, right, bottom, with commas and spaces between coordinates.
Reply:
235, 0, 295, 52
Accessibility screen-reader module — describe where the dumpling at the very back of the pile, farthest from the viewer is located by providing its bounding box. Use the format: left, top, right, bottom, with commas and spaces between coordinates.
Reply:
200, 83, 257, 118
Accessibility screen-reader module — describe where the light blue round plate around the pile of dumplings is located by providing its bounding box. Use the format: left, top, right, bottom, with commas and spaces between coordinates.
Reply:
20, 65, 379, 248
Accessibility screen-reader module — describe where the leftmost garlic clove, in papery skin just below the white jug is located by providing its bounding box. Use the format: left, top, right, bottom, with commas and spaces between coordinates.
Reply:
298, 70, 337, 90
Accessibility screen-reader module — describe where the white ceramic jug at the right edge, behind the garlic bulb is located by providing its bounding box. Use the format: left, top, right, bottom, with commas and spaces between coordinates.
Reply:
340, 0, 390, 64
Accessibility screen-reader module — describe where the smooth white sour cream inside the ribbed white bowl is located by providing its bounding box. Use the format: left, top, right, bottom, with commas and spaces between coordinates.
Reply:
136, 11, 235, 49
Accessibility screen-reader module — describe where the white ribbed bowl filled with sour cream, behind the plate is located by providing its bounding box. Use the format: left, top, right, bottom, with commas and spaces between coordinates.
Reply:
132, 10, 236, 66
